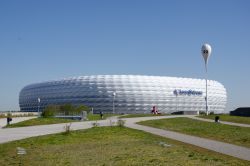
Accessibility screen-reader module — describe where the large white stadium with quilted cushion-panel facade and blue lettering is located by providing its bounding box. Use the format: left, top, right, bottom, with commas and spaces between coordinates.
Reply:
19, 75, 227, 114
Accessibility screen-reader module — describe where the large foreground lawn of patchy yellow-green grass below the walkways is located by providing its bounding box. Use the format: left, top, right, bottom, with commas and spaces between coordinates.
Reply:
0, 127, 247, 166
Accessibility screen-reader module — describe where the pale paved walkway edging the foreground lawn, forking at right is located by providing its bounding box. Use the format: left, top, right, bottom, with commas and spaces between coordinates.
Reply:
0, 115, 250, 161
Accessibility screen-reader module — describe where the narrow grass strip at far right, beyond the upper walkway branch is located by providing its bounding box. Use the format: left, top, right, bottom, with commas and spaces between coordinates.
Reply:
198, 115, 250, 124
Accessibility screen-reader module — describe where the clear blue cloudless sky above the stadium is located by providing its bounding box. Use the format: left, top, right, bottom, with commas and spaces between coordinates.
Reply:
0, 0, 250, 111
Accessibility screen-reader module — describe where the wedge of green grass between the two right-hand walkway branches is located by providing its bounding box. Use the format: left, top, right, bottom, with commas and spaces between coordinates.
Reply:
138, 118, 250, 147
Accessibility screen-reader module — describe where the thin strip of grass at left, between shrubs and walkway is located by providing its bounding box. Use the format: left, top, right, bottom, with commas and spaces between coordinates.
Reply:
6, 118, 78, 128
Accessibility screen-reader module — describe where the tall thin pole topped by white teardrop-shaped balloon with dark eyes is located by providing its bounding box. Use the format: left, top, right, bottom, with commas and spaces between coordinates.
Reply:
201, 44, 212, 115
